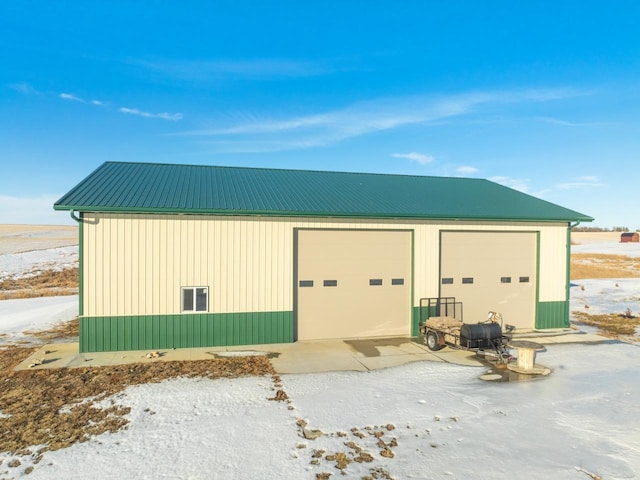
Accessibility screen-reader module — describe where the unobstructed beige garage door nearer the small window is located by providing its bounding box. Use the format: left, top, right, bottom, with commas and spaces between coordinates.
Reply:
296, 230, 411, 340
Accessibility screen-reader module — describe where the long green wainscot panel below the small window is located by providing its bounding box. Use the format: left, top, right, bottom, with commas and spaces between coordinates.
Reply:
80, 311, 293, 353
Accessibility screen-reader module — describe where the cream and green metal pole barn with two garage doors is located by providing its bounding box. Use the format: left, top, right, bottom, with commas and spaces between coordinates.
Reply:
54, 162, 592, 352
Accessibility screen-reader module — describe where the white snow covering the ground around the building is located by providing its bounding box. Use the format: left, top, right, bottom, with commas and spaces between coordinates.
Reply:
0, 230, 640, 480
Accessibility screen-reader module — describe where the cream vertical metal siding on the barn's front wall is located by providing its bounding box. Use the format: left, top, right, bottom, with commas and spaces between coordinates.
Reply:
83, 213, 567, 316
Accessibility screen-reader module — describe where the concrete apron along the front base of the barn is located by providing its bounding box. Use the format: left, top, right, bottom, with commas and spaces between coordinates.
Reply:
15, 331, 608, 374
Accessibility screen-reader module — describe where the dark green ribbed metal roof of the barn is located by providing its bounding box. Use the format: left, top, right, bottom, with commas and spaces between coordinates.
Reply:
54, 162, 593, 222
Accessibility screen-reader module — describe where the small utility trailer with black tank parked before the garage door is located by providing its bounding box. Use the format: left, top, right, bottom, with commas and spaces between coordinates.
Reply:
420, 297, 515, 363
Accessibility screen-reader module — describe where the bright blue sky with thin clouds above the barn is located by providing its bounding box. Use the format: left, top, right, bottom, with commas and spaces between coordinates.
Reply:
0, 0, 640, 230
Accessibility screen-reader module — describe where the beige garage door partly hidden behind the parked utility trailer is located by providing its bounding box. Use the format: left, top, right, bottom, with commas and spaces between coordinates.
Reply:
440, 232, 537, 328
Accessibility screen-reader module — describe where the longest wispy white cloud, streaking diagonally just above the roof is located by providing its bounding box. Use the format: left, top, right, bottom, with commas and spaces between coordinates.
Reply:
179, 90, 585, 151
